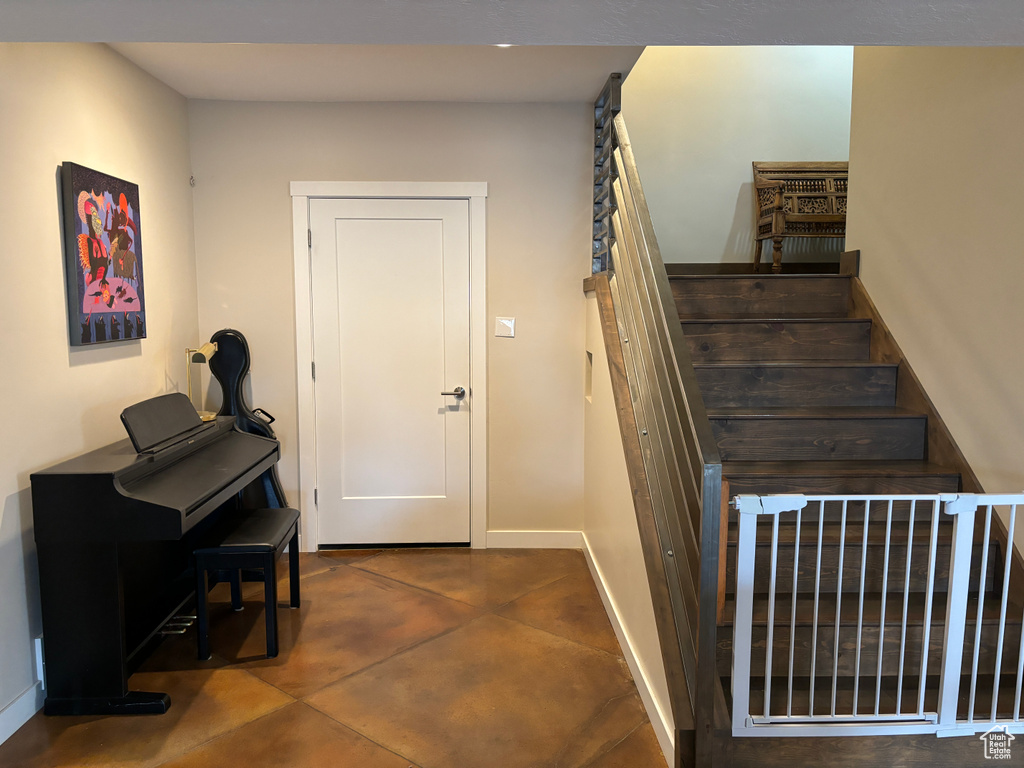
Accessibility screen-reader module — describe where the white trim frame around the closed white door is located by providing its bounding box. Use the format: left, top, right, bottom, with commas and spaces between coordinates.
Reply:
291, 181, 487, 552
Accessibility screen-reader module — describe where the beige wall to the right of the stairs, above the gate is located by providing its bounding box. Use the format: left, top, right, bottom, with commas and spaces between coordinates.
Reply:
848, 48, 1024, 493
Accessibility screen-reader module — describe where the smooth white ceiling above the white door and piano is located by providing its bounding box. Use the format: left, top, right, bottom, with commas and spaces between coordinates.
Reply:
111, 43, 643, 101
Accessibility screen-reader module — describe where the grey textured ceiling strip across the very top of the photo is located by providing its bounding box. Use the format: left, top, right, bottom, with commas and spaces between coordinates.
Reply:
0, 0, 1024, 45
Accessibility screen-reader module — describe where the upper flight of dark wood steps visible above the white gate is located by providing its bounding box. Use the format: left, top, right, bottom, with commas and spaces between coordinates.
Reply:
671, 274, 961, 495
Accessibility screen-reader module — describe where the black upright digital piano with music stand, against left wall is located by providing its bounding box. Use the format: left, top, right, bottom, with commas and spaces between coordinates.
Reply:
32, 395, 280, 715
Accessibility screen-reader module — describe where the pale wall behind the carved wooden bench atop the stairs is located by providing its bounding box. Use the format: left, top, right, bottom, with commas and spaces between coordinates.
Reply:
623, 46, 853, 262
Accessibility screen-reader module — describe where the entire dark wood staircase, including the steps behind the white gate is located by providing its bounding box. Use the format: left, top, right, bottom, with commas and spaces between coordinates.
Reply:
670, 273, 1024, 766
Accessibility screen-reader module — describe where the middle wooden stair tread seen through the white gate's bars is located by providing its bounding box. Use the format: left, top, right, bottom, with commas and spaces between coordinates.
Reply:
718, 592, 1022, 626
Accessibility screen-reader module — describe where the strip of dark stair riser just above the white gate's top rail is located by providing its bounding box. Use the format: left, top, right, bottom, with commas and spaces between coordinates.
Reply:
726, 475, 959, 496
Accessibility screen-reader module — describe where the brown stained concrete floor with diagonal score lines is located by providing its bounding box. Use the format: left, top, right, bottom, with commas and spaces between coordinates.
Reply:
0, 549, 666, 768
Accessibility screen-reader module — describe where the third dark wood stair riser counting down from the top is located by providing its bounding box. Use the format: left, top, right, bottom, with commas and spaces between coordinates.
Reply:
696, 366, 896, 409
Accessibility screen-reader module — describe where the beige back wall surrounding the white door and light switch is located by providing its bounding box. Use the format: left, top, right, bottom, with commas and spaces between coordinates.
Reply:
189, 101, 593, 530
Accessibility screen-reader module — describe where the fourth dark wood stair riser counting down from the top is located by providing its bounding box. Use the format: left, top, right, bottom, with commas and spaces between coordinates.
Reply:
711, 416, 927, 461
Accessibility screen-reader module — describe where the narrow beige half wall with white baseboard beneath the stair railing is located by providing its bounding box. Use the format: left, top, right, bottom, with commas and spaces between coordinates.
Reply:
584, 293, 675, 755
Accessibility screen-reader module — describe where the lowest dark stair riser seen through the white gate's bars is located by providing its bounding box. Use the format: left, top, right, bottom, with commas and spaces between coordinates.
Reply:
717, 626, 1021, 678
